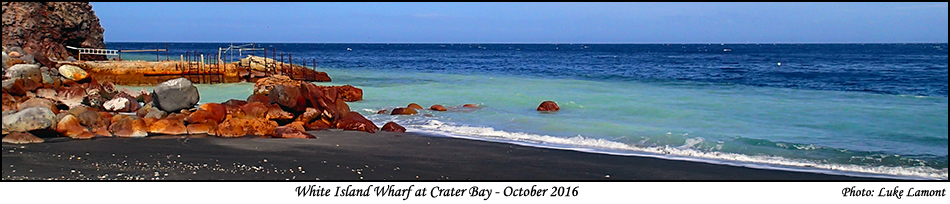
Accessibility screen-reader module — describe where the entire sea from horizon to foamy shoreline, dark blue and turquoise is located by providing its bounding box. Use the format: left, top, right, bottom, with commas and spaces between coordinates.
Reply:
106, 43, 948, 180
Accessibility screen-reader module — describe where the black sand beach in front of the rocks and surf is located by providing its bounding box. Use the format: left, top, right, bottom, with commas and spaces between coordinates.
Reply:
2, 130, 877, 181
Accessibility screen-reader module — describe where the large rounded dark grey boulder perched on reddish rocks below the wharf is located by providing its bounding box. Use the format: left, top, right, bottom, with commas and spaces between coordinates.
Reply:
152, 78, 200, 112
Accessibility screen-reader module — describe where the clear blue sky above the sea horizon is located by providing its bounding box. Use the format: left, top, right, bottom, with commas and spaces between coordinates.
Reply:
92, 2, 948, 43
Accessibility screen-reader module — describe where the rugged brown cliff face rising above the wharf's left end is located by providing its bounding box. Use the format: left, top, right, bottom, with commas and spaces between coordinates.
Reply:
2, 2, 105, 60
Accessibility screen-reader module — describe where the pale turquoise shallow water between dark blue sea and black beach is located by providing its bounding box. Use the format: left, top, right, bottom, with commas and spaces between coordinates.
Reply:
115, 66, 947, 179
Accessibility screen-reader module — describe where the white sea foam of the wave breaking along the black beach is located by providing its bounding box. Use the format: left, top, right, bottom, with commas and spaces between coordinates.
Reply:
406, 120, 948, 180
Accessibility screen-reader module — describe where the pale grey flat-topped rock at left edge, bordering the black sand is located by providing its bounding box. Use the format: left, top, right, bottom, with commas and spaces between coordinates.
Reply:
3, 107, 56, 132
